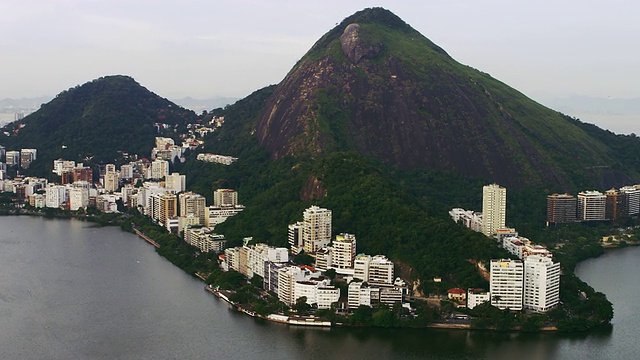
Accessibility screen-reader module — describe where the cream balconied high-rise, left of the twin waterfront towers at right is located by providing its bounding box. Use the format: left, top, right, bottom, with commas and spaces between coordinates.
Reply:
489, 259, 524, 310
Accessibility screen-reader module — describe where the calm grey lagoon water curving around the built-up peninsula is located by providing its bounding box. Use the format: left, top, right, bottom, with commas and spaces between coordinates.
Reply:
0, 217, 640, 359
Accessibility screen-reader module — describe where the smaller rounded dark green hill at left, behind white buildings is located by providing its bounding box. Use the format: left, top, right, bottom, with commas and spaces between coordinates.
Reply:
0, 75, 196, 176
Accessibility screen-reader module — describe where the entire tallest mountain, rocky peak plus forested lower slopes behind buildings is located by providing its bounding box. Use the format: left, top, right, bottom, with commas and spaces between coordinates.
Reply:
190, 9, 640, 292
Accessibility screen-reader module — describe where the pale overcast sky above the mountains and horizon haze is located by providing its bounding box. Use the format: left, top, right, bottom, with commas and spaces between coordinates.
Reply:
0, 0, 640, 133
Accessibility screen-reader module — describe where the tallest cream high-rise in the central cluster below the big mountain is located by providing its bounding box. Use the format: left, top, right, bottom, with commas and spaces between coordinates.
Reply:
302, 206, 331, 254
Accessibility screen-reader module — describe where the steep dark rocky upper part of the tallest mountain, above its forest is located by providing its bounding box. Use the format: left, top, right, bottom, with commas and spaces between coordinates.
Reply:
255, 8, 638, 189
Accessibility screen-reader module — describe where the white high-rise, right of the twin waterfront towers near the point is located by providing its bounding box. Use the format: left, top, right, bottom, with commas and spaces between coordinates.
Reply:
524, 255, 560, 312
